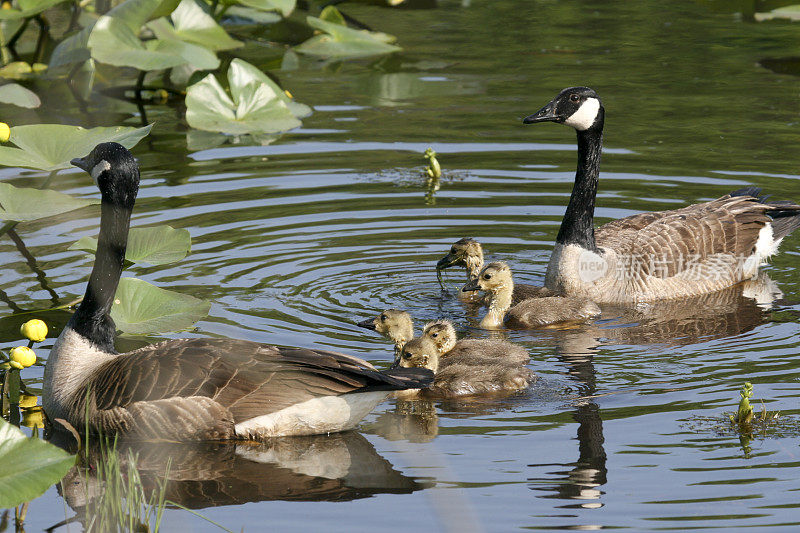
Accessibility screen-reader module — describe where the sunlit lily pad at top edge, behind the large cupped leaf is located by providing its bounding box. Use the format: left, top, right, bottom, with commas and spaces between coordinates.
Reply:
147, 0, 243, 51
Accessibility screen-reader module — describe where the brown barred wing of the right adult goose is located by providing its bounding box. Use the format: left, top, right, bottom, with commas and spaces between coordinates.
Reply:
596, 189, 776, 278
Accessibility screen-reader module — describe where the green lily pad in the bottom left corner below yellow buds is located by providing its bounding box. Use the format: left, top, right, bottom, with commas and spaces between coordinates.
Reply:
0, 418, 75, 509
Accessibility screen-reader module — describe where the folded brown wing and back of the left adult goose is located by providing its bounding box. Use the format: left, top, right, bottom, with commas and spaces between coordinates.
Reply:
90, 339, 431, 421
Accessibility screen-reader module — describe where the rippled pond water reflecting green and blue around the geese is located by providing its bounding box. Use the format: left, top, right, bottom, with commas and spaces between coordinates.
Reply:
0, 0, 800, 531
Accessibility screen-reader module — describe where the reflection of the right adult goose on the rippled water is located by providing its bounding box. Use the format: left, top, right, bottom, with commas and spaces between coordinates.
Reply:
528, 273, 783, 508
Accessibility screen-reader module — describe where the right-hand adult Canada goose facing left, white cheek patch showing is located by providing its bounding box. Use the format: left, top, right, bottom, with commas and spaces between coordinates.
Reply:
523, 87, 800, 303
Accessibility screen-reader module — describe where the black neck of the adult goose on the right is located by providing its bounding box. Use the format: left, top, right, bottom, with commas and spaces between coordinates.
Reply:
556, 123, 603, 252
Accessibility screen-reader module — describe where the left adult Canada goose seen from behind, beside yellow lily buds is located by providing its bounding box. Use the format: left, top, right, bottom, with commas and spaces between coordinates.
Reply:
43, 143, 431, 440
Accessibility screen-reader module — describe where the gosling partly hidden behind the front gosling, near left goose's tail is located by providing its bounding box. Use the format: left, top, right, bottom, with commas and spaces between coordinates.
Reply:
422, 319, 530, 363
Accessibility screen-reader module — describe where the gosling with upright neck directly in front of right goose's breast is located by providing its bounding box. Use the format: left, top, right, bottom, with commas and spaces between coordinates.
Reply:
464, 261, 600, 329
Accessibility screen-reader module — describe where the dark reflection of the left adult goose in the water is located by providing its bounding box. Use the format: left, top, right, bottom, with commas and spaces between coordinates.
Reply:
51, 431, 431, 519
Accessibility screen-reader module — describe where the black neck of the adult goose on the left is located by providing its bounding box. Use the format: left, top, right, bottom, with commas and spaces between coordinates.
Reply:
68, 200, 133, 353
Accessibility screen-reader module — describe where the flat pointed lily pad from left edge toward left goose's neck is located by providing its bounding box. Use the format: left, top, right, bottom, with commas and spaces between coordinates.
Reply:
0, 182, 100, 222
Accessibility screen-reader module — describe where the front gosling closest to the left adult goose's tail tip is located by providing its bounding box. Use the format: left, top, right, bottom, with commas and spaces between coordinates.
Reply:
395, 336, 536, 399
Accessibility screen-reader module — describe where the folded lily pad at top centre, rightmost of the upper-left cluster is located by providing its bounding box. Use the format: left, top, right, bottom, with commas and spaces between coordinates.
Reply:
295, 17, 402, 58
